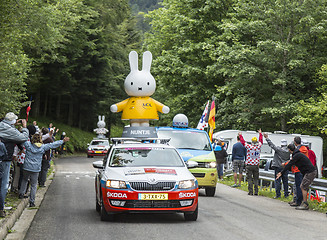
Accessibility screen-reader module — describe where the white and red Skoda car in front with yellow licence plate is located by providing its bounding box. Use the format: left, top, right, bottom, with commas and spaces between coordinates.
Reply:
93, 139, 198, 221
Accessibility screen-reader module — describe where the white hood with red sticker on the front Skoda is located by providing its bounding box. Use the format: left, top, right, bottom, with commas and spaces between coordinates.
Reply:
106, 167, 195, 182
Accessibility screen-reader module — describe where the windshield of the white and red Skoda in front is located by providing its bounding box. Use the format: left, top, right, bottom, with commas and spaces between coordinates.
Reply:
109, 148, 184, 167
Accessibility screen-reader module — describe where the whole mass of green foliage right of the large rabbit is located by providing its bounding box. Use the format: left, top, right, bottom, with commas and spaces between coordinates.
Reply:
144, 0, 327, 131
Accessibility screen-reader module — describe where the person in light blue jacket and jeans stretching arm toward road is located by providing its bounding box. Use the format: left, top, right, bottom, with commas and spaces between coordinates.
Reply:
19, 134, 69, 207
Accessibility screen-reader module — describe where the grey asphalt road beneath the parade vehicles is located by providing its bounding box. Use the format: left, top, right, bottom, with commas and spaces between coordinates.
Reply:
25, 157, 327, 240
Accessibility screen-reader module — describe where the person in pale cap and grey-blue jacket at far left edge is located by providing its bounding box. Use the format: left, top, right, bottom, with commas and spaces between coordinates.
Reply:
0, 112, 29, 217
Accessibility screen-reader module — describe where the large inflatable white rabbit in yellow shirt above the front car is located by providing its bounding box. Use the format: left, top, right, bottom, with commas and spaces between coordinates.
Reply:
110, 51, 169, 127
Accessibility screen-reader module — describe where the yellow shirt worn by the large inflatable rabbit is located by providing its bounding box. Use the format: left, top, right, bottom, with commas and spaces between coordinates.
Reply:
116, 97, 164, 120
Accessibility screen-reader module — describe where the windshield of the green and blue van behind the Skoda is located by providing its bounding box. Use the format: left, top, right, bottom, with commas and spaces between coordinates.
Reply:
158, 130, 211, 151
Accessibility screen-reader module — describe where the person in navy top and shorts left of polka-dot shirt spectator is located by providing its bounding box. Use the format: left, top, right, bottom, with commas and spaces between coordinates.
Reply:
232, 136, 246, 187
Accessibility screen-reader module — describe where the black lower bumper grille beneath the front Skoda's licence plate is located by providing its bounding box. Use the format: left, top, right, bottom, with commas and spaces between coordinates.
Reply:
124, 200, 181, 208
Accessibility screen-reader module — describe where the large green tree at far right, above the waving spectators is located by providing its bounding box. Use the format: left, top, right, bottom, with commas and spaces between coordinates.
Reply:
215, 0, 327, 131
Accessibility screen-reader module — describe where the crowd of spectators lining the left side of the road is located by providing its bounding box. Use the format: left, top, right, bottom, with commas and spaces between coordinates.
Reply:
0, 112, 69, 217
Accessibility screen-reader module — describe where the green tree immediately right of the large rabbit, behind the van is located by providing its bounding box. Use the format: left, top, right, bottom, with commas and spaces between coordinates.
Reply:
144, 0, 232, 126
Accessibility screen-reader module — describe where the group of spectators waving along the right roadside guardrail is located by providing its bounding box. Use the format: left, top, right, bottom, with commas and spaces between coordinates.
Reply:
213, 129, 318, 210
